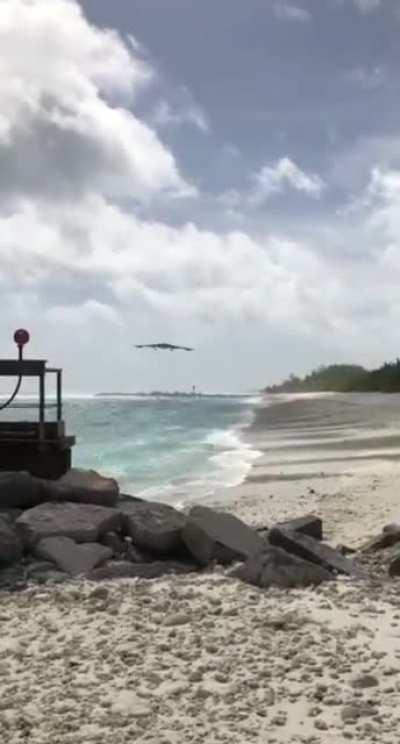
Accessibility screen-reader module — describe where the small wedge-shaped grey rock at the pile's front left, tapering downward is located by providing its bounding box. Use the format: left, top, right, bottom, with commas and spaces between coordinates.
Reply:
34, 537, 112, 576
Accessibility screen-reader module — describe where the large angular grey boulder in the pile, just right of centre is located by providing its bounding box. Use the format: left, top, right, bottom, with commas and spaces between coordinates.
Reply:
182, 506, 263, 566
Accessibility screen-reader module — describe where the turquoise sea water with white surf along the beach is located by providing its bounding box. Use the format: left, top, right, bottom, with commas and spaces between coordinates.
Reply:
60, 396, 255, 504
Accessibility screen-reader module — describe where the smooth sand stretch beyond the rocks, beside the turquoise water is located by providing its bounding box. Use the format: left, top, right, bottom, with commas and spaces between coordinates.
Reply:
207, 394, 400, 547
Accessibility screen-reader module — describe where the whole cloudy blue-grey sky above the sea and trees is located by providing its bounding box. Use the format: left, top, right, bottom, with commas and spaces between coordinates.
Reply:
0, 0, 400, 393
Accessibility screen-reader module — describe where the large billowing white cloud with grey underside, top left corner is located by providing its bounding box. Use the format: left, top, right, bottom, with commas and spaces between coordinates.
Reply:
0, 0, 194, 201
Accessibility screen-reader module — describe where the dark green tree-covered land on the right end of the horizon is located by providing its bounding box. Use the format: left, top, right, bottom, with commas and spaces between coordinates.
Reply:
263, 359, 400, 393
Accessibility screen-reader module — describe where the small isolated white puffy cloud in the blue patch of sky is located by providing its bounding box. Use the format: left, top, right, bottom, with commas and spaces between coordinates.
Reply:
251, 157, 325, 204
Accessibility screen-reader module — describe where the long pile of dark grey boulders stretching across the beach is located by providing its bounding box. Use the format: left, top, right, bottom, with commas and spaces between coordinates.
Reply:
0, 470, 390, 588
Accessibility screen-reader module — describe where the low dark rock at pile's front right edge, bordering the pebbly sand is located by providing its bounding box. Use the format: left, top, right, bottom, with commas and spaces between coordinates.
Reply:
230, 546, 332, 589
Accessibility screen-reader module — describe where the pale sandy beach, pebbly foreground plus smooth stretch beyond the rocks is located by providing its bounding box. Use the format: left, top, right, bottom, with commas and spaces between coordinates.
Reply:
0, 396, 400, 744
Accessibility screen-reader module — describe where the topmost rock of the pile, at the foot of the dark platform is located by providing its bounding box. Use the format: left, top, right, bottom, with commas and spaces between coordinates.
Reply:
42, 468, 119, 506
